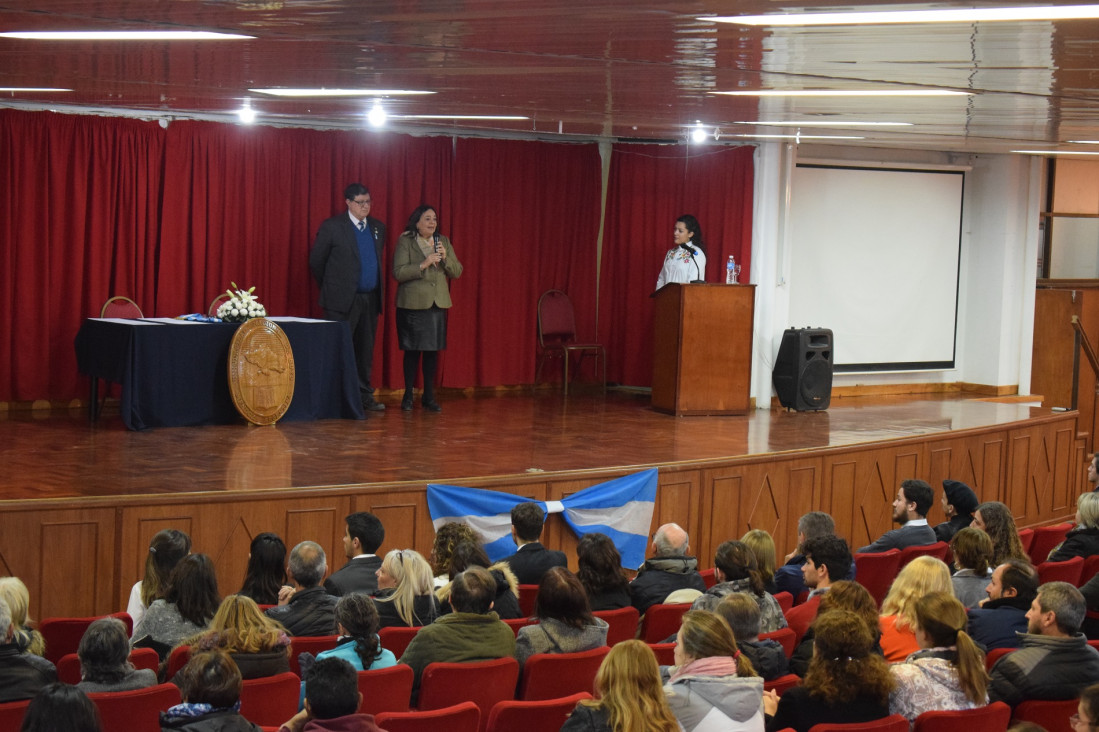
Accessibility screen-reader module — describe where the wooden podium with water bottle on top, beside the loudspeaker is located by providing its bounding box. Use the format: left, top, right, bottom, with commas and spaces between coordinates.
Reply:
653, 282, 755, 417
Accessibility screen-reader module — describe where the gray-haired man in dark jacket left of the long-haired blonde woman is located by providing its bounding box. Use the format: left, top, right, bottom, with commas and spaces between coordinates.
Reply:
267, 542, 338, 635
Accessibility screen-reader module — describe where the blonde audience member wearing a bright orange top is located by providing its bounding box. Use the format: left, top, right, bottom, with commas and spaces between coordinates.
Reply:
881, 556, 954, 663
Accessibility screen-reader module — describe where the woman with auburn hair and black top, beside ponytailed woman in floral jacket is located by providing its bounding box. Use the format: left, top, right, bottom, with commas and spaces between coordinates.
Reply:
764, 610, 895, 732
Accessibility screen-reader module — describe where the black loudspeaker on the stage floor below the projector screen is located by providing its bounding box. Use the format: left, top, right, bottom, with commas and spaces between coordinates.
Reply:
771, 328, 832, 412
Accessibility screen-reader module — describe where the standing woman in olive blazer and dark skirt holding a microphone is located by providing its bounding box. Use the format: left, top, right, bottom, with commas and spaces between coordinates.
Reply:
393, 206, 462, 412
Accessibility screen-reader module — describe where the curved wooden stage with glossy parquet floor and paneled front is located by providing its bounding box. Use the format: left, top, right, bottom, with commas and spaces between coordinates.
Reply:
0, 395, 1085, 618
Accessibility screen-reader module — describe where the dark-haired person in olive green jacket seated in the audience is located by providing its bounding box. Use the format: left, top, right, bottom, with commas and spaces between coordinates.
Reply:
400, 566, 515, 697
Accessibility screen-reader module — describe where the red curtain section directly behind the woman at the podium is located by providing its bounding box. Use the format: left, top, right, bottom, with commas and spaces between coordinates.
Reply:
599, 139, 755, 386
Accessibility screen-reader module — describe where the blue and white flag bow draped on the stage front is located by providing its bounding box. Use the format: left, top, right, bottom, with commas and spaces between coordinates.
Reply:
428, 468, 657, 568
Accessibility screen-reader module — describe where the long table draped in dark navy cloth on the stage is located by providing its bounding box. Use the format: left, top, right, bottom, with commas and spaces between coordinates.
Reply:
76, 318, 364, 430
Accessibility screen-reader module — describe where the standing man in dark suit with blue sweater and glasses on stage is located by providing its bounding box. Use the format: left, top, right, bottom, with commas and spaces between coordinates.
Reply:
309, 184, 386, 412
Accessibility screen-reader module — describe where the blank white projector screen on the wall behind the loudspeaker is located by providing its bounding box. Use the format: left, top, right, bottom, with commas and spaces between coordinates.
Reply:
788, 164, 965, 371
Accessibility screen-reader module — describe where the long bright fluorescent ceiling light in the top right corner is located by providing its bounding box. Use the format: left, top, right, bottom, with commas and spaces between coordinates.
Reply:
698, 5, 1099, 25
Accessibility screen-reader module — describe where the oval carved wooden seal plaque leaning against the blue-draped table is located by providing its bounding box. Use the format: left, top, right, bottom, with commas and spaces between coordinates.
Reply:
229, 318, 293, 424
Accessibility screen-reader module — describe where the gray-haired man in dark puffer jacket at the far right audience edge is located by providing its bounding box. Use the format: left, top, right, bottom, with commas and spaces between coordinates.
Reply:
988, 583, 1099, 707
